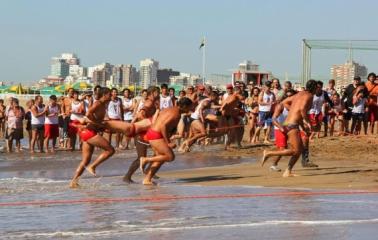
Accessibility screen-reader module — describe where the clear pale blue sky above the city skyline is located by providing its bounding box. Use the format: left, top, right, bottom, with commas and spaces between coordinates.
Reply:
0, 0, 378, 82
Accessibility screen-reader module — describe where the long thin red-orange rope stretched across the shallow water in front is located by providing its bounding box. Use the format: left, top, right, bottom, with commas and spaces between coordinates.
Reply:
0, 190, 378, 207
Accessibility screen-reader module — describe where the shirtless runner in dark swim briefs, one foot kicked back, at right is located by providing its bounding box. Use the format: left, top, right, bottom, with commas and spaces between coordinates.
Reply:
262, 80, 317, 177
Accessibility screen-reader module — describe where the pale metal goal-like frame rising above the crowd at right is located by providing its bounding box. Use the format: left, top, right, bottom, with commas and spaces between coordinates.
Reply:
301, 39, 378, 85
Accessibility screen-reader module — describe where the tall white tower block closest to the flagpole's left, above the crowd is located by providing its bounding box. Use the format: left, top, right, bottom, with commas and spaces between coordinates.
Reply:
139, 58, 159, 88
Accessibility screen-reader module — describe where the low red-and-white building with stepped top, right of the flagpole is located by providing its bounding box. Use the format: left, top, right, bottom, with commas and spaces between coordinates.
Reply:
232, 61, 272, 85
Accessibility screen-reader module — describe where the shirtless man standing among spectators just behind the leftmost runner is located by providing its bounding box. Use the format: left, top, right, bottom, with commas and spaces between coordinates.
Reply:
61, 88, 75, 149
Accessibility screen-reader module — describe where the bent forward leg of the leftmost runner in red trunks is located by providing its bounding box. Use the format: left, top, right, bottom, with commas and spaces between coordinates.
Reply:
87, 135, 115, 176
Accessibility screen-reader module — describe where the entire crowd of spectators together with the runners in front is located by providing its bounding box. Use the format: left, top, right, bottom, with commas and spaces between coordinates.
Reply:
0, 73, 378, 188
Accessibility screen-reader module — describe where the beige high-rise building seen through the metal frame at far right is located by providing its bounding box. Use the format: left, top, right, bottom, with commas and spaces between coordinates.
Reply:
331, 60, 367, 89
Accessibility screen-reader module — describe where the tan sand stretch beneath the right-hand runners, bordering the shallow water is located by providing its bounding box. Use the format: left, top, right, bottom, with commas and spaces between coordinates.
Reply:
160, 136, 378, 189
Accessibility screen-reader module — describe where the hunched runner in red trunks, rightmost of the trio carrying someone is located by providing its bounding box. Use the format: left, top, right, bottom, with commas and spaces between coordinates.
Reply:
140, 98, 193, 185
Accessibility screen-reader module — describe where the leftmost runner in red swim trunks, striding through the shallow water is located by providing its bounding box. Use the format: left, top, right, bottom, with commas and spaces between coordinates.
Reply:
70, 88, 115, 188
